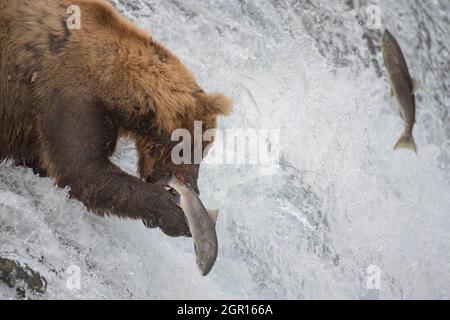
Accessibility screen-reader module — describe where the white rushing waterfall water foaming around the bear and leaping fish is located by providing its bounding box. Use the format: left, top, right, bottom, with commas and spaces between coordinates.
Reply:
0, 0, 450, 299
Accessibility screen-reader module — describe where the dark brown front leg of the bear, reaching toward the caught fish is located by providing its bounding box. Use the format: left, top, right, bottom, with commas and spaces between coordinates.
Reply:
41, 99, 189, 236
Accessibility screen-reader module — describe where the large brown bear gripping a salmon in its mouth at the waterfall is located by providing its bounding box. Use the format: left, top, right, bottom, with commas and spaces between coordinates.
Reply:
0, 0, 231, 236
